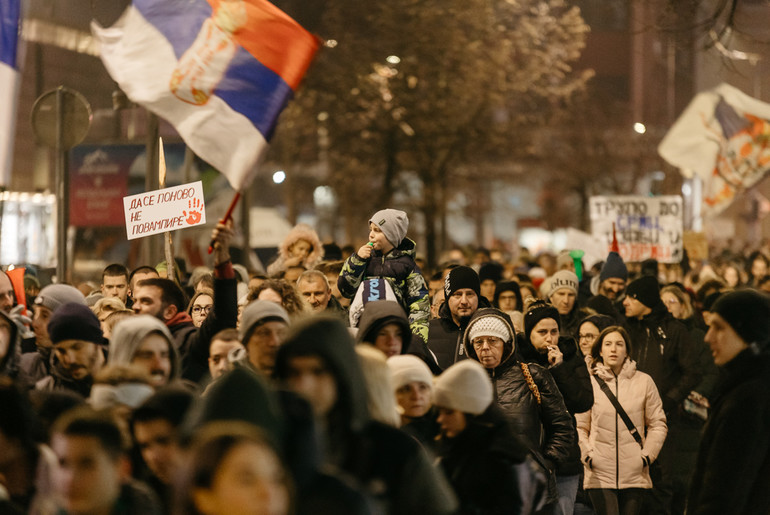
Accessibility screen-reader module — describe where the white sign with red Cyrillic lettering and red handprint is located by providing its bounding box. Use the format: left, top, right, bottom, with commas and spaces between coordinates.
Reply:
123, 181, 206, 240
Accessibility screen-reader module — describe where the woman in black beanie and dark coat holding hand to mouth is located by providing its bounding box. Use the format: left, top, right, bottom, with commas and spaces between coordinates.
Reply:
517, 302, 594, 513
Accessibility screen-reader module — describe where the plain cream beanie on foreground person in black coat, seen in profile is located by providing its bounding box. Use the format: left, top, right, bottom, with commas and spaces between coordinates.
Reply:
433, 359, 494, 415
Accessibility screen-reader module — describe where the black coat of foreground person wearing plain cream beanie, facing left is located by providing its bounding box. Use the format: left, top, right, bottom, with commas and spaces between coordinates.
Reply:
438, 403, 528, 515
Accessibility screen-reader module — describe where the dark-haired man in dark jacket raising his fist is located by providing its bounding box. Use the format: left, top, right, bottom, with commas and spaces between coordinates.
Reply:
133, 223, 238, 382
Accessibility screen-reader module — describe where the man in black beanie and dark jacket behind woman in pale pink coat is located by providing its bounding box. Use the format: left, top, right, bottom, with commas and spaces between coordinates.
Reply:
623, 276, 703, 513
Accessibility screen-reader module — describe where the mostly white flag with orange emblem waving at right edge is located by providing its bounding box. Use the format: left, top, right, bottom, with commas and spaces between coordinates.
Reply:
658, 84, 770, 215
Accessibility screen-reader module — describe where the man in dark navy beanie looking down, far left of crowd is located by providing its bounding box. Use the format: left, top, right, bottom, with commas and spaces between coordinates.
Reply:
35, 303, 107, 398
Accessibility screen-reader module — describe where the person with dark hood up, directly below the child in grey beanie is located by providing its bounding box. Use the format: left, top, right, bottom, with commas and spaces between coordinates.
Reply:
356, 300, 438, 370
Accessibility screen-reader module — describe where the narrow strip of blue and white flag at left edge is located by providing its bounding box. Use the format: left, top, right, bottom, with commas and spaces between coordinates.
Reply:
0, 0, 21, 187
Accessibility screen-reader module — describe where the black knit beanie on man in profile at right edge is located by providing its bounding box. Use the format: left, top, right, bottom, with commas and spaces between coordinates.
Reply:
711, 290, 770, 346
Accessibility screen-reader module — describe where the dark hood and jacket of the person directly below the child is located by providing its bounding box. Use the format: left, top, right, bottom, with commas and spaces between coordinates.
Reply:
356, 300, 438, 373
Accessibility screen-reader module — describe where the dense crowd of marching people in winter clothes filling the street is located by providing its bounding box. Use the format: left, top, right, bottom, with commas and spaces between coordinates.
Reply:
0, 209, 770, 515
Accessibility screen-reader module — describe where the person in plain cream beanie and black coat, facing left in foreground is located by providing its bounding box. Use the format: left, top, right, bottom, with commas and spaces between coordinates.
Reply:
435, 360, 545, 513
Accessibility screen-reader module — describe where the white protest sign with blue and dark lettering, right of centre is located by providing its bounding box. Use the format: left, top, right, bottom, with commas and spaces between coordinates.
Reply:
590, 195, 683, 263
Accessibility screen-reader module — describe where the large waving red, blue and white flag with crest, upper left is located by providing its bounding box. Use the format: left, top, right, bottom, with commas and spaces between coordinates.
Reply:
91, 0, 320, 191
